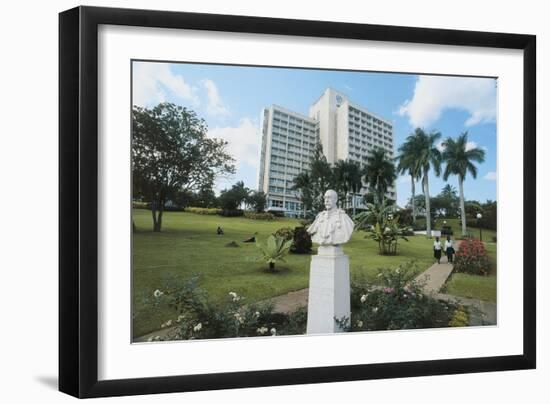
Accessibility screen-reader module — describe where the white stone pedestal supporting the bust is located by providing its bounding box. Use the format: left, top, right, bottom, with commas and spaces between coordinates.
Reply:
307, 246, 350, 334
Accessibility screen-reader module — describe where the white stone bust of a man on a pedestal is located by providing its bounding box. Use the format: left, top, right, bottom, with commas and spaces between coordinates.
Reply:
307, 189, 354, 246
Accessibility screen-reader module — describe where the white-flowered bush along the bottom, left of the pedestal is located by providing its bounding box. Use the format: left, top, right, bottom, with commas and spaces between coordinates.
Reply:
150, 277, 306, 342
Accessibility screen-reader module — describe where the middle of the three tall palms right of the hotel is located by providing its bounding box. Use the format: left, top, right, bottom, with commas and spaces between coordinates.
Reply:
411, 128, 441, 238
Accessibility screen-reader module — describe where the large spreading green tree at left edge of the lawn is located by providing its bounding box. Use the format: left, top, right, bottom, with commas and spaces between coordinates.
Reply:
132, 103, 235, 231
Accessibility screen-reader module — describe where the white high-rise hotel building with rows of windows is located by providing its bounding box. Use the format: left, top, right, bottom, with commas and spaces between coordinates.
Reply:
258, 88, 396, 217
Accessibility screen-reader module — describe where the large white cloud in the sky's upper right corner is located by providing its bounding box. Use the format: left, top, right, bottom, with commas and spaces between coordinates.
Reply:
398, 76, 496, 127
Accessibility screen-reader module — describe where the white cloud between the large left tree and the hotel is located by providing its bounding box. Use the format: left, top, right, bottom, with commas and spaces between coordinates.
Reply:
208, 118, 260, 168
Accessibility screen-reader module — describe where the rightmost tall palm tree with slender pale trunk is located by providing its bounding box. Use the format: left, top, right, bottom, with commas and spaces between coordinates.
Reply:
443, 132, 485, 235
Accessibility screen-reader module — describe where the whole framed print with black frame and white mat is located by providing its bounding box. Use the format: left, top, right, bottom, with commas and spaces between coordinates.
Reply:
59, 7, 536, 398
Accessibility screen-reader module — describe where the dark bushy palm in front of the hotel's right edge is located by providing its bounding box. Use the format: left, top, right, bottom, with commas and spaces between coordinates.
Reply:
364, 149, 397, 204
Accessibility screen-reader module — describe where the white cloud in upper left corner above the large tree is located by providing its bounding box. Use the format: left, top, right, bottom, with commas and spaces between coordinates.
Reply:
132, 62, 199, 107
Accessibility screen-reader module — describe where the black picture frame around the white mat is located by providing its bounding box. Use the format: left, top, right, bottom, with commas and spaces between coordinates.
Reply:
59, 7, 536, 398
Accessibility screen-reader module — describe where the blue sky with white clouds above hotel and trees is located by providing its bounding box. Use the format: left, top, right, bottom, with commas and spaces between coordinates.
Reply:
132, 61, 497, 206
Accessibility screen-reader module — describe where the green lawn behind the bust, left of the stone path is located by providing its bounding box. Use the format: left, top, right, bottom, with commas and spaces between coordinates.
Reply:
133, 209, 496, 336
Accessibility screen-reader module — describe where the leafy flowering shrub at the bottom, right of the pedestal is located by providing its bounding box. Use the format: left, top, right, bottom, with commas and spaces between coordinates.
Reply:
345, 262, 456, 331
